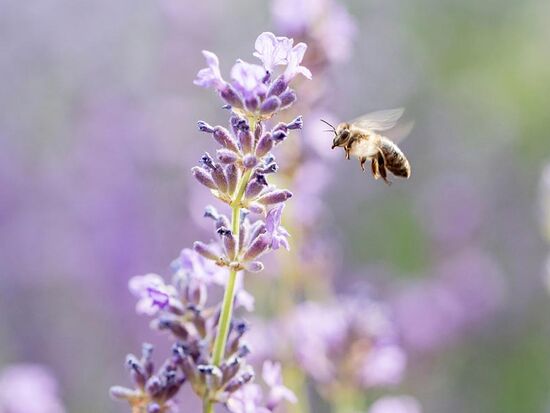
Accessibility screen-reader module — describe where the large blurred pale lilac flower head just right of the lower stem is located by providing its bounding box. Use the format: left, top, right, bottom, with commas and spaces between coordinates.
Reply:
287, 297, 406, 388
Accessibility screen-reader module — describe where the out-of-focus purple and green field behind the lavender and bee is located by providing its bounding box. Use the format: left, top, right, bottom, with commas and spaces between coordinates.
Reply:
0, 0, 550, 413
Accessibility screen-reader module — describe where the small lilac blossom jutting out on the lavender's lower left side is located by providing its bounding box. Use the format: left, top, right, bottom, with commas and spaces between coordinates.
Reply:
128, 273, 176, 315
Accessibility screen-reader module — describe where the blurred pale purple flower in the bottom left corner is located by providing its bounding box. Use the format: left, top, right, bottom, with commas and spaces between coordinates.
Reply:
0, 364, 65, 413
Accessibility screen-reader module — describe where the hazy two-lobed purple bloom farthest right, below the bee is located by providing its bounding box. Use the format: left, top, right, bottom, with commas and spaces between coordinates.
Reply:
395, 250, 503, 351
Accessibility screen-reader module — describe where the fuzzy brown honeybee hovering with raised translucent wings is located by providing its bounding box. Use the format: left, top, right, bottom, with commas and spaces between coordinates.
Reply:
321, 108, 411, 185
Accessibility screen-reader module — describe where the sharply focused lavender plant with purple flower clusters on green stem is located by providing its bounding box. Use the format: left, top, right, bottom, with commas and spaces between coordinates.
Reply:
111, 32, 311, 413
